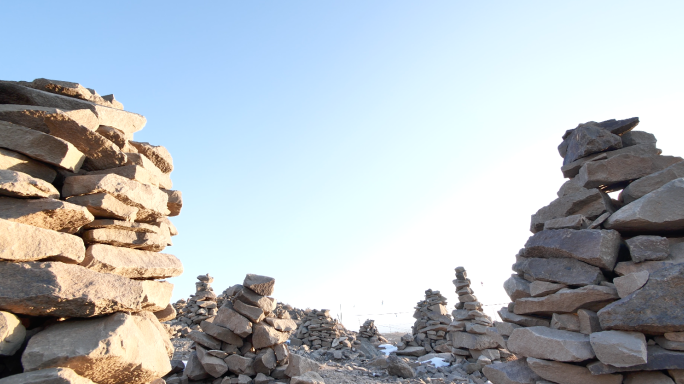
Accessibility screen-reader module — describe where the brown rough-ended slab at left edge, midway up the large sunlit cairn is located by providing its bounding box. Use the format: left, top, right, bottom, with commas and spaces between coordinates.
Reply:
0, 197, 95, 233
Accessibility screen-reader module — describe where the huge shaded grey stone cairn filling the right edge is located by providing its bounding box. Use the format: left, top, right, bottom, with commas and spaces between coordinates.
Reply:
483, 118, 684, 384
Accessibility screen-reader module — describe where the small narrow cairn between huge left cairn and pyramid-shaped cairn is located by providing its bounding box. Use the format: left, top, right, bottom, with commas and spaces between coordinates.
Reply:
167, 273, 218, 338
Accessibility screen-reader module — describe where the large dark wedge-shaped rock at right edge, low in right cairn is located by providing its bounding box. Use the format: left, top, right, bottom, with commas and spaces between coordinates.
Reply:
598, 264, 684, 334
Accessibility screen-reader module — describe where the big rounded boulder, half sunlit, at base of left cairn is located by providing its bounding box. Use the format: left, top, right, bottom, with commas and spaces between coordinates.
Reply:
21, 313, 173, 384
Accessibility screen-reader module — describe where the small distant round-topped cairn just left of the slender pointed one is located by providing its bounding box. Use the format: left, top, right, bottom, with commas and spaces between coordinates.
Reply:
412, 289, 451, 353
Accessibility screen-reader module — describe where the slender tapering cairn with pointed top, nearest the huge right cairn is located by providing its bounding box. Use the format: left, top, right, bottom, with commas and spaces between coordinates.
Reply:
449, 267, 511, 373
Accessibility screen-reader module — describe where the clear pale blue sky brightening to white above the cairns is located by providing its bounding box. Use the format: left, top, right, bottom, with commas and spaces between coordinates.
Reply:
0, 0, 684, 332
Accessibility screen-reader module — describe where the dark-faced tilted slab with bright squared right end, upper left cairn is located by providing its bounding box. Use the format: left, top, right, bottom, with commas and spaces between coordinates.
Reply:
0, 121, 85, 172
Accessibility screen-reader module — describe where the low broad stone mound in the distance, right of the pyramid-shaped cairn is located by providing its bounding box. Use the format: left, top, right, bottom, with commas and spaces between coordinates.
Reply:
290, 309, 355, 350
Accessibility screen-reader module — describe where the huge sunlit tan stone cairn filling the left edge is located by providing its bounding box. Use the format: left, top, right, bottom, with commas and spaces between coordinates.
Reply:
0, 79, 183, 384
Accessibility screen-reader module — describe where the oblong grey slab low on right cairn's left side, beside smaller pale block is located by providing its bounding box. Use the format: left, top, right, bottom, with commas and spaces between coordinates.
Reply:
507, 327, 596, 362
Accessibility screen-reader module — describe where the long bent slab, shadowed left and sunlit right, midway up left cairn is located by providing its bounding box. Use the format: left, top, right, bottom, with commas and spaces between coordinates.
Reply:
62, 174, 169, 221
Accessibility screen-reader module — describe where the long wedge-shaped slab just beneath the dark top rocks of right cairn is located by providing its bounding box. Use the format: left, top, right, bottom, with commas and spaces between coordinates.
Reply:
578, 154, 684, 188
